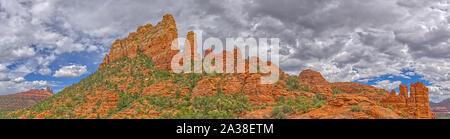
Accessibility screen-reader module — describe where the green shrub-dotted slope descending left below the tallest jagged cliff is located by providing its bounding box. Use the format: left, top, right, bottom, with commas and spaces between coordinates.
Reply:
3, 54, 254, 119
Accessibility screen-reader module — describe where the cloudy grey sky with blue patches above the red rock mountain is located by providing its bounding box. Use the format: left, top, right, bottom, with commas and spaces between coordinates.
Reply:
0, 0, 450, 102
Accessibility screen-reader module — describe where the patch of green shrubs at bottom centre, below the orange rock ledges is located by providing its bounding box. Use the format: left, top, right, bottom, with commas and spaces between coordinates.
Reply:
155, 94, 253, 119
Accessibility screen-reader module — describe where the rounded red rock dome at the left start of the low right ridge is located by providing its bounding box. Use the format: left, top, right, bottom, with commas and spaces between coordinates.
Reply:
297, 70, 331, 97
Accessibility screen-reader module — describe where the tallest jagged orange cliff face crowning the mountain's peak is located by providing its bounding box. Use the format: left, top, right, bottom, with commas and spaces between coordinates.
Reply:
100, 15, 179, 70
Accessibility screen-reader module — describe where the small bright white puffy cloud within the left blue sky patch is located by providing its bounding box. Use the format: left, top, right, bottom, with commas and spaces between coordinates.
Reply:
53, 65, 87, 78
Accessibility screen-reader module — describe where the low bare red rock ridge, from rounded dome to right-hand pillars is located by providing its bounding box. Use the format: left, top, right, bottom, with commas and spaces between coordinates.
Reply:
296, 70, 435, 119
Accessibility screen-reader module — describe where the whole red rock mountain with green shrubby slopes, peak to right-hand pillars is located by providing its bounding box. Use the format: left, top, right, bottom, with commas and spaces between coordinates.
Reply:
6, 15, 434, 119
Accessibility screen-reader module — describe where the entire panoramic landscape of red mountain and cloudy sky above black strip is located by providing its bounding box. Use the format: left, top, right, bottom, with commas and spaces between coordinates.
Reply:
0, 0, 450, 136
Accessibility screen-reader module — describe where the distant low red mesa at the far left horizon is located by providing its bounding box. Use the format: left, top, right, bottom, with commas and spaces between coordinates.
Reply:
0, 87, 53, 111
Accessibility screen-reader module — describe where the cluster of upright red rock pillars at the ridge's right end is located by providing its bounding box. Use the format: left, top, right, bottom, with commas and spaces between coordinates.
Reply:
381, 82, 434, 119
